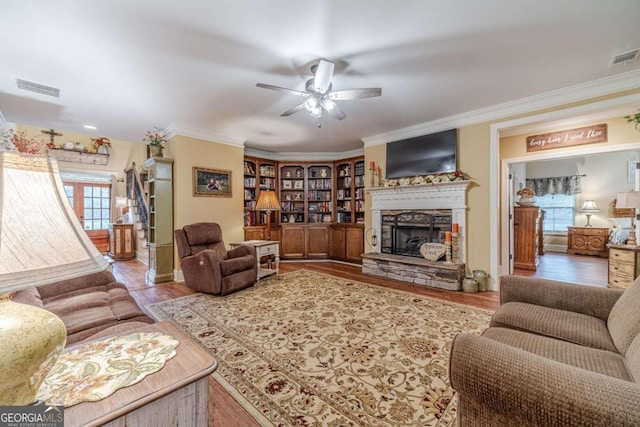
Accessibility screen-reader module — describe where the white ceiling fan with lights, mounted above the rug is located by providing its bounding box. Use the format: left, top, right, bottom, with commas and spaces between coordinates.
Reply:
256, 59, 382, 123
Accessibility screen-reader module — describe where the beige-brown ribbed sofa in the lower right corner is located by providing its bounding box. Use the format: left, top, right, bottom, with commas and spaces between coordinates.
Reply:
450, 276, 640, 427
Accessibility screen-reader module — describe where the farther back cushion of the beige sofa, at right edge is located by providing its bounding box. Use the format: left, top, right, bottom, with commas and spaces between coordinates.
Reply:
607, 277, 640, 355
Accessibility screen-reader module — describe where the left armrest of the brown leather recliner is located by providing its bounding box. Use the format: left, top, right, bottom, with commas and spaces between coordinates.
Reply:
180, 249, 222, 294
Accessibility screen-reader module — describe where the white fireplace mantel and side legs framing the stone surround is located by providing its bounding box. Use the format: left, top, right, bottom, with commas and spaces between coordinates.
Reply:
367, 180, 472, 262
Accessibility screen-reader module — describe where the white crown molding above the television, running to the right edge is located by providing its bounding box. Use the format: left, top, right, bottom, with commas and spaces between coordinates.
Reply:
362, 70, 640, 147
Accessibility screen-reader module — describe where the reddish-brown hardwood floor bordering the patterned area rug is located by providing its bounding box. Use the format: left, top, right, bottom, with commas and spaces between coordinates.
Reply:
113, 260, 500, 427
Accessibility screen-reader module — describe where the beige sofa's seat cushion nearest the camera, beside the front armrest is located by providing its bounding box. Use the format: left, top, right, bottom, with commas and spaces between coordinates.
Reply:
482, 327, 633, 381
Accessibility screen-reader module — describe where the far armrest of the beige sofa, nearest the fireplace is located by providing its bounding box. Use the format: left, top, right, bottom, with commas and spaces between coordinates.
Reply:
500, 275, 624, 321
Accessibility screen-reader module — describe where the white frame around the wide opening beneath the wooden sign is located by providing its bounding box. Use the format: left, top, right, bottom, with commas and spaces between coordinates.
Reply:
489, 94, 640, 290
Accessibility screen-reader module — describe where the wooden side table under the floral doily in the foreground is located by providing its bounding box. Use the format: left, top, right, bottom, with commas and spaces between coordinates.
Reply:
64, 322, 218, 427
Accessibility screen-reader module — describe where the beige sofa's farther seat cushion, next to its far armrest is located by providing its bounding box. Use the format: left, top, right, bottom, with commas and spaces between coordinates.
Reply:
490, 302, 617, 352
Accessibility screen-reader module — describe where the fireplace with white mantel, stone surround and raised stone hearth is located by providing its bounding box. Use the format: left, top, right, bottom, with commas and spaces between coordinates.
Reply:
362, 181, 470, 290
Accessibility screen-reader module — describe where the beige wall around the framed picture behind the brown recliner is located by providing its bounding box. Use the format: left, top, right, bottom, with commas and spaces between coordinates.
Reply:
170, 135, 244, 267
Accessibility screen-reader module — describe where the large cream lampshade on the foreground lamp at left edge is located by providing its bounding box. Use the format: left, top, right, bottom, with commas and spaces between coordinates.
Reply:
0, 152, 108, 293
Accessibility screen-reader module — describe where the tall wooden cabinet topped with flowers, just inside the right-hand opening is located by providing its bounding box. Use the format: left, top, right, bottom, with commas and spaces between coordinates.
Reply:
513, 206, 540, 271
